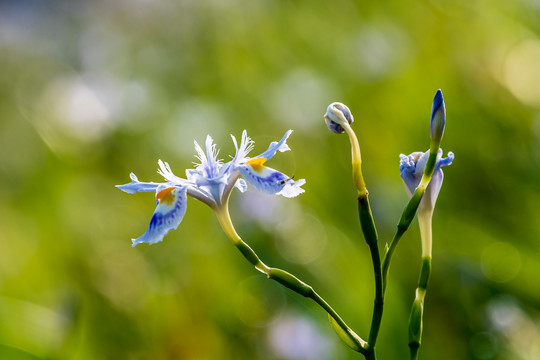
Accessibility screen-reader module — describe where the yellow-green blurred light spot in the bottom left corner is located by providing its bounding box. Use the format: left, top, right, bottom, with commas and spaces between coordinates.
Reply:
0, 297, 68, 358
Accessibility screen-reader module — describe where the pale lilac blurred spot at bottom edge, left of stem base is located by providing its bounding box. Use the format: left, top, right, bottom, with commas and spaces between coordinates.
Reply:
268, 313, 332, 360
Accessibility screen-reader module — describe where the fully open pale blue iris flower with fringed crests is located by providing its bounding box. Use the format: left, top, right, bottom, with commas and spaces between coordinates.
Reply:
117, 130, 306, 246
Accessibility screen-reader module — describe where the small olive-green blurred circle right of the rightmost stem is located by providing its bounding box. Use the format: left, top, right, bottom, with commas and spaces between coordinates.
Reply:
482, 242, 521, 283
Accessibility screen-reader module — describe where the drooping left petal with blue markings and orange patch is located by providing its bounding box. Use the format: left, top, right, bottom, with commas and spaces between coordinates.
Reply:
132, 186, 187, 246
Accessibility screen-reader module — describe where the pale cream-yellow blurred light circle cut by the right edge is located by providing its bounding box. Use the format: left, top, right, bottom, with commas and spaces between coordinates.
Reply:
503, 40, 540, 106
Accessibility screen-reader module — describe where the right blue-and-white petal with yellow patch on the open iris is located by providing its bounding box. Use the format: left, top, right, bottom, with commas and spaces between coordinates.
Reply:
238, 158, 305, 197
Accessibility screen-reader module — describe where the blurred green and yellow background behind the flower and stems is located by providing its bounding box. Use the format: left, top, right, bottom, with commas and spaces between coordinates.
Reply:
0, 0, 540, 360
